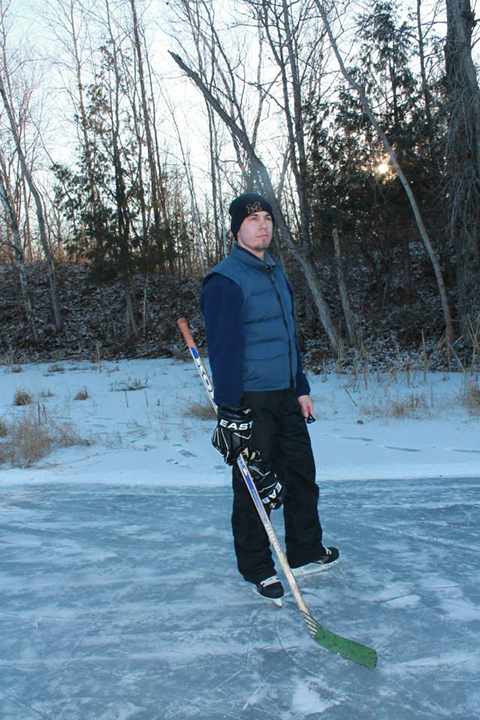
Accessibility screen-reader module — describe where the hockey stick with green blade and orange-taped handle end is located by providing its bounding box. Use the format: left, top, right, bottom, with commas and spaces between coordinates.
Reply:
177, 318, 377, 668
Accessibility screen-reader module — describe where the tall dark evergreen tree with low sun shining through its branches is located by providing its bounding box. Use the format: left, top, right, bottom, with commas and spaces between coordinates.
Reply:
308, 0, 438, 296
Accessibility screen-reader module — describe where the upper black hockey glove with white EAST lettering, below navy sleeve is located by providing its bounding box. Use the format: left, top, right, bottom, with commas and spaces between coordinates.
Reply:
212, 405, 253, 465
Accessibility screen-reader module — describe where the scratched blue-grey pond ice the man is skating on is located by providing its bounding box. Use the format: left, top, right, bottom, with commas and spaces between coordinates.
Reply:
0, 473, 480, 720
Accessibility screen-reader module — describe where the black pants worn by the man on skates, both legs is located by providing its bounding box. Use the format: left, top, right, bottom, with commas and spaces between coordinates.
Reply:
232, 389, 323, 583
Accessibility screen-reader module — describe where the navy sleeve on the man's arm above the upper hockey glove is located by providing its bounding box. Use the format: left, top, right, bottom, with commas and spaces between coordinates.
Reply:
200, 273, 245, 407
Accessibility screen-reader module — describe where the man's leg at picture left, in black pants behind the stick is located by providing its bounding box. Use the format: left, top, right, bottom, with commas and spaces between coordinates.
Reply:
232, 391, 281, 583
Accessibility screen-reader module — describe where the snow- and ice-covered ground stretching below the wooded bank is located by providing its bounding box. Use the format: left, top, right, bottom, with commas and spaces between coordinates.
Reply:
0, 359, 480, 720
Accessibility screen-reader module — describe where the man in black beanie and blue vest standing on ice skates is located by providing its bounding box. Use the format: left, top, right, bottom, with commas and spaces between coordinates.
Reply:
200, 193, 339, 600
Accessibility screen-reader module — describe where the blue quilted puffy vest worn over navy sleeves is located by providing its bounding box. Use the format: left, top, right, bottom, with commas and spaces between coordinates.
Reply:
207, 245, 297, 392
